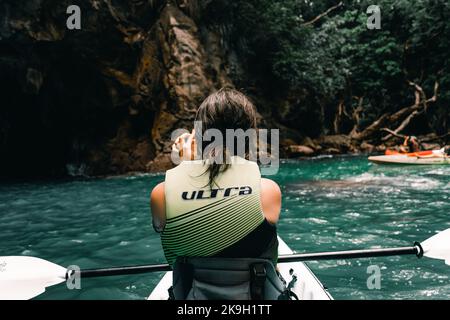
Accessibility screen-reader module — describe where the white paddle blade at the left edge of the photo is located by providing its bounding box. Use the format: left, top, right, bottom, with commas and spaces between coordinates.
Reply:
0, 256, 66, 300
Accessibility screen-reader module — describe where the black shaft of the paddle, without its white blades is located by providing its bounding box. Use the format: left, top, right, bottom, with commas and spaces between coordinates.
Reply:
76, 243, 423, 278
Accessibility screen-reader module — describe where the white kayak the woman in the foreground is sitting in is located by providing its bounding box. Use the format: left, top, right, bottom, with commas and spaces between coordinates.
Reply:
148, 238, 333, 300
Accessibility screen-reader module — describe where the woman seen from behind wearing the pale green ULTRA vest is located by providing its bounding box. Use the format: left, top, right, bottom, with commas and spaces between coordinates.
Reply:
150, 89, 281, 265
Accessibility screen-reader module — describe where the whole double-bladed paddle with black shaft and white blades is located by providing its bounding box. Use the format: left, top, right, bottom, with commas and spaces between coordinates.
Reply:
0, 229, 450, 300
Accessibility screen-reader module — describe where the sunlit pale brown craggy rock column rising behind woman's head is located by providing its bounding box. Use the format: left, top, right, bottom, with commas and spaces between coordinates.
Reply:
152, 5, 231, 152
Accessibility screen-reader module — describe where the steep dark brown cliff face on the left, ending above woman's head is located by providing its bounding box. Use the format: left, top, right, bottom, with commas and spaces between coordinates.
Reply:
0, 0, 232, 177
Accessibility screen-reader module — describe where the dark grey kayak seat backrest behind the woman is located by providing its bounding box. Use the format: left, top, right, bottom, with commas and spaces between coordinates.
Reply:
169, 258, 298, 300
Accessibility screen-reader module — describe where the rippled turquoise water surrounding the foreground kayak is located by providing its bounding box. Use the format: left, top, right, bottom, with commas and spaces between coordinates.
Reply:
0, 157, 450, 299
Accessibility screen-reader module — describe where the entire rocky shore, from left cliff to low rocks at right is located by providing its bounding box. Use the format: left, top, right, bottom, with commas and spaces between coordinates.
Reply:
0, 0, 450, 178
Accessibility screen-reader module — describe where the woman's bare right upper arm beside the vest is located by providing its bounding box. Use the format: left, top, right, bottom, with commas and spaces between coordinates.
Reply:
261, 178, 281, 224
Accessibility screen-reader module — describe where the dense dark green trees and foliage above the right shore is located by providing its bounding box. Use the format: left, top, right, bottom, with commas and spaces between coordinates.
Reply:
204, 0, 450, 139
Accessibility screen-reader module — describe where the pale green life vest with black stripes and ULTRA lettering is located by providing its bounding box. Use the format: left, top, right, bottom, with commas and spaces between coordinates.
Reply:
161, 157, 278, 265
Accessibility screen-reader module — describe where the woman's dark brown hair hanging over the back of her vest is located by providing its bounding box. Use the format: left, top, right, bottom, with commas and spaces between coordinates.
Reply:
195, 88, 256, 187
